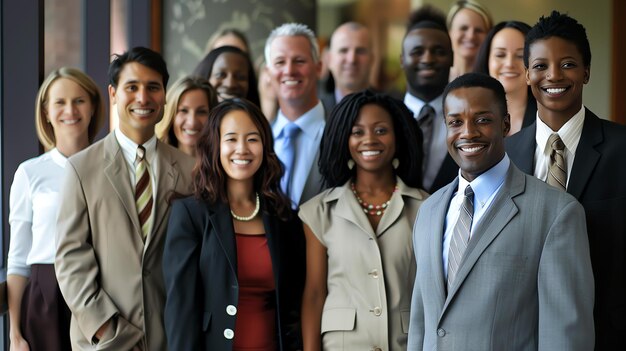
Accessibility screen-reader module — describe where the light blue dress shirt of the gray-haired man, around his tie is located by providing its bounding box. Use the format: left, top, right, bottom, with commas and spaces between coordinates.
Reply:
272, 101, 326, 205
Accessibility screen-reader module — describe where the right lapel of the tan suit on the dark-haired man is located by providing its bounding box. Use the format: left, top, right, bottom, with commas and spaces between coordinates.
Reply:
146, 141, 178, 246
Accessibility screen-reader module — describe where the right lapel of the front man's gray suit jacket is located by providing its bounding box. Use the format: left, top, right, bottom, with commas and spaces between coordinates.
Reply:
444, 164, 526, 311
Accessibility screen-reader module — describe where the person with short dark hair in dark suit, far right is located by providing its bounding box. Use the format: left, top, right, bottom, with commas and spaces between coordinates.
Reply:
506, 11, 626, 350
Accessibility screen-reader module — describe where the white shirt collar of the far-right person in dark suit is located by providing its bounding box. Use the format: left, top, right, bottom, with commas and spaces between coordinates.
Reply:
535, 106, 585, 155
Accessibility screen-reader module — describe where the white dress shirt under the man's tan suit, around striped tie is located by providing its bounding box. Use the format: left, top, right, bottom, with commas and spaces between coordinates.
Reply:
115, 129, 158, 234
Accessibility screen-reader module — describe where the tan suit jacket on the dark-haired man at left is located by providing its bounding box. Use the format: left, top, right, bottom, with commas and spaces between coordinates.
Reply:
55, 133, 193, 351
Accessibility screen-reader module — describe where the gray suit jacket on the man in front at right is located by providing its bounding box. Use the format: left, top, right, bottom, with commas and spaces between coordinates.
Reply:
408, 163, 594, 351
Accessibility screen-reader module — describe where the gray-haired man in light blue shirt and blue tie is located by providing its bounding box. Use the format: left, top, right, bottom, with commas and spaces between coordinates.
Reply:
265, 23, 325, 208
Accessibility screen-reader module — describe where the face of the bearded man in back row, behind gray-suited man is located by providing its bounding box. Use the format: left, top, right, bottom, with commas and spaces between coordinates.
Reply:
400, 28, 452, 102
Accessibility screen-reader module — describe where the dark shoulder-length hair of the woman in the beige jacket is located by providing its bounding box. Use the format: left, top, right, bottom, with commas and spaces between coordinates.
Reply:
318, 89, 423, 188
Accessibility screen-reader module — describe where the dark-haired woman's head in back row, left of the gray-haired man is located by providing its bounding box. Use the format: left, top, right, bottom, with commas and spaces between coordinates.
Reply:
193, 46, 259, 106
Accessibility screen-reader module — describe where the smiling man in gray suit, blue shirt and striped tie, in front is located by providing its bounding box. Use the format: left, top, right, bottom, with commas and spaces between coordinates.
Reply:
408, 73, 594, 351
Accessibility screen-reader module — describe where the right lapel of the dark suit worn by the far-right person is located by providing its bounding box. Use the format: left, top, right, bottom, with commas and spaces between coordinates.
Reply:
567, 109, 604, 199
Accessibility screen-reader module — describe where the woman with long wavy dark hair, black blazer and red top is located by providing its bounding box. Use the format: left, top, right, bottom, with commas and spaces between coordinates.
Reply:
163, 99, 304, 351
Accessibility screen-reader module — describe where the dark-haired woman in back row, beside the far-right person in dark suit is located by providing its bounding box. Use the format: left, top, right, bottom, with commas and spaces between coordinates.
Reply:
474, 21, 537, 135
